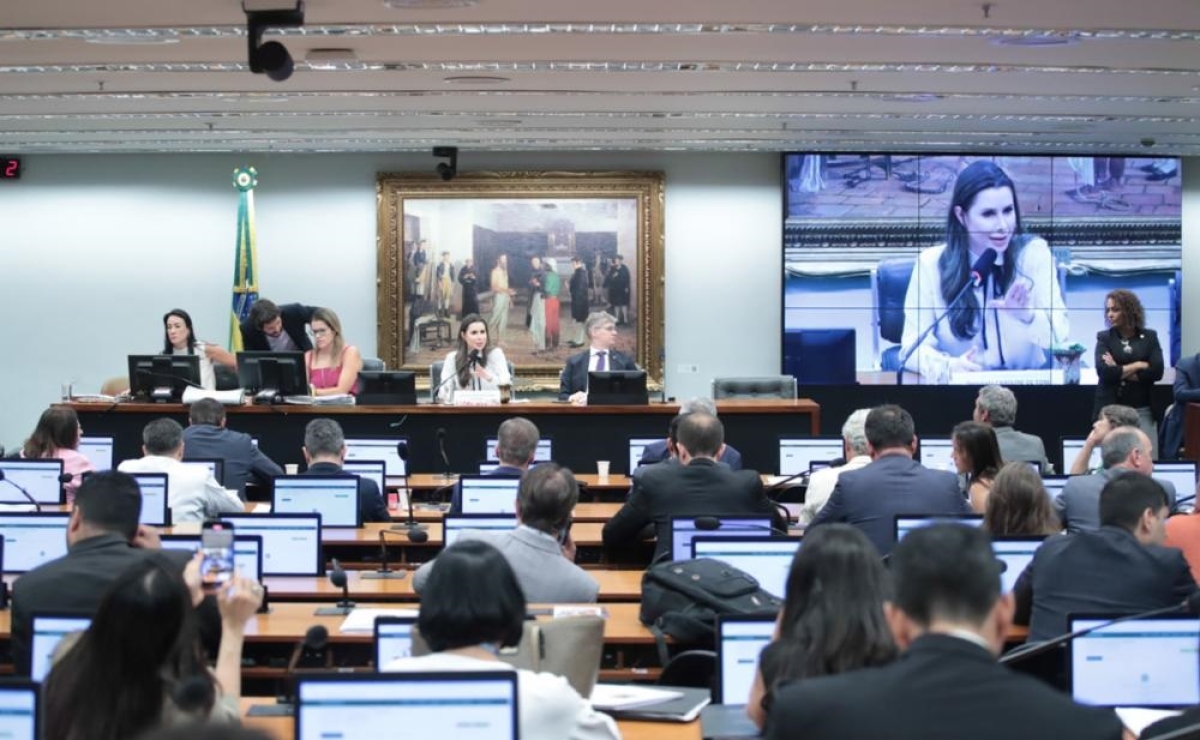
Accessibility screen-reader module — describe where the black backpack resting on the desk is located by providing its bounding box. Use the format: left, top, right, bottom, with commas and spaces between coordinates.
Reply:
638, 558, 784, 664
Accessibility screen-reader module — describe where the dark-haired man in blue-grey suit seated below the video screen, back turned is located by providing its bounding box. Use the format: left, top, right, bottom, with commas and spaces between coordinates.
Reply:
809, 405, 971, 555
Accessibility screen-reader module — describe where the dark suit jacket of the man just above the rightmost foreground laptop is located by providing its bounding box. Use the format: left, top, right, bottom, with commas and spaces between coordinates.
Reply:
1013, 527, 1196, 642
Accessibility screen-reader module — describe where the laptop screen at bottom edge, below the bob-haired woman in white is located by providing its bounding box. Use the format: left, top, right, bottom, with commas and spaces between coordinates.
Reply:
295, 670, 517, 740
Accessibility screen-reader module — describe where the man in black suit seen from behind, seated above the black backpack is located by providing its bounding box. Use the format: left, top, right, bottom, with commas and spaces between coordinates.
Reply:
604, 413, 787, 561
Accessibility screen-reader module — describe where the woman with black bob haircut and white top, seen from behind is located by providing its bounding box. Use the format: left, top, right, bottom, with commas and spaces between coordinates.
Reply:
383, 540, 620, 740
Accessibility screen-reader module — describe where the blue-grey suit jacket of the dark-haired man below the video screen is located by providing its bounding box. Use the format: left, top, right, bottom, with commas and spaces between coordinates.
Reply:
809, 455, 971, 555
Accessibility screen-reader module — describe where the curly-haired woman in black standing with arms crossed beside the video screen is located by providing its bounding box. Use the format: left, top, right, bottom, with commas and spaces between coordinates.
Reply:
1092, 290, 1163, 450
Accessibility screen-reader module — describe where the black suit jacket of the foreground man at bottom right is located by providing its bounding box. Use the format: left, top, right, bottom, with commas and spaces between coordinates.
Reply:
766, 634, 1122, 740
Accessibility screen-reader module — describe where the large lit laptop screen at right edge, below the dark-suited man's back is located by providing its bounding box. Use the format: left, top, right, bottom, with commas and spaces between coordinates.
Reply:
1069, 616, 1200, 706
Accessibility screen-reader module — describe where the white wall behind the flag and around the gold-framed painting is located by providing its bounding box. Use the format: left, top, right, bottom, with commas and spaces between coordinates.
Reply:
0, 152, 777, 447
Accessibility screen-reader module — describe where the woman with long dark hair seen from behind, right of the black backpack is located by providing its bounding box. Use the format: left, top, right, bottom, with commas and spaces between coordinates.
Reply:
746, 524, 896, 729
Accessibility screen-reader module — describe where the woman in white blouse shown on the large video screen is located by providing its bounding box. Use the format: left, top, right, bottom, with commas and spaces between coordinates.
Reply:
900, 160, 1068, 383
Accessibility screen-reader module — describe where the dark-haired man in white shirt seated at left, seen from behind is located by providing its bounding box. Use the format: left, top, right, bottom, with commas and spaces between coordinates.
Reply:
118, 419, 246, 524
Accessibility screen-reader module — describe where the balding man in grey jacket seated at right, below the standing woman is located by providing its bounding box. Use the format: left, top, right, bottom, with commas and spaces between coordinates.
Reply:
1054, 427, 1175, 533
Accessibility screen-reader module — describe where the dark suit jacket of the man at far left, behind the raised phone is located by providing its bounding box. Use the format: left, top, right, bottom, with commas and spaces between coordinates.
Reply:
12, 533, 196, 675
